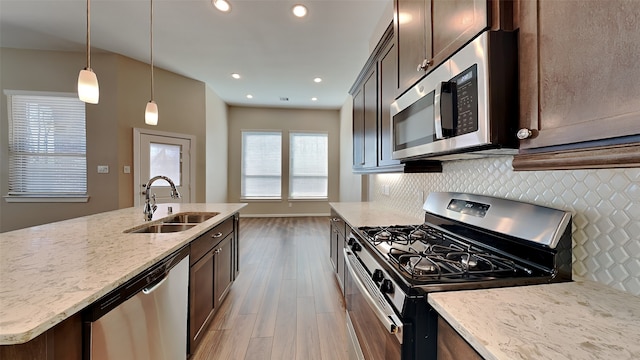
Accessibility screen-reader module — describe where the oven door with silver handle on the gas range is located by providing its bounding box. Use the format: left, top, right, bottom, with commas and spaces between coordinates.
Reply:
344, 248, 403, 360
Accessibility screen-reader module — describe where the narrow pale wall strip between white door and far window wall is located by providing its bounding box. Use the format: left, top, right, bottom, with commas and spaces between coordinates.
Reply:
206, 87, 229, 203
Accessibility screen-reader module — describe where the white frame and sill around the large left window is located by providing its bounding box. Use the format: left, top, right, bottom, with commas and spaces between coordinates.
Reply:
3, 90, 89, 203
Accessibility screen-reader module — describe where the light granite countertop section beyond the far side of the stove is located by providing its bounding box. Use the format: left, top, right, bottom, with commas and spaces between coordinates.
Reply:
329, 202, 424, 228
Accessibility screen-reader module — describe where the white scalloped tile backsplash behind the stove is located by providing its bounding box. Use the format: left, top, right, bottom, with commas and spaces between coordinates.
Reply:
370, 156, 640, 295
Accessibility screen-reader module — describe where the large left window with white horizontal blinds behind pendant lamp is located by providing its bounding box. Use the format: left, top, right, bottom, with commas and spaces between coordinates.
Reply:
5, 91, 87, 201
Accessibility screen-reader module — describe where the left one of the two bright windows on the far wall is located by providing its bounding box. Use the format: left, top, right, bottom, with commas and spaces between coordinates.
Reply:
241, 131, 282, 199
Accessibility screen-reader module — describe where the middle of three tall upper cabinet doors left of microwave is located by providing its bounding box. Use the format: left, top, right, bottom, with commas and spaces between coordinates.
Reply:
362, 68, 378, 168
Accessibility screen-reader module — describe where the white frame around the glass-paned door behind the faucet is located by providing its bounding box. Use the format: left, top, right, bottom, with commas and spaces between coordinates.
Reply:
133, 128, 196, 206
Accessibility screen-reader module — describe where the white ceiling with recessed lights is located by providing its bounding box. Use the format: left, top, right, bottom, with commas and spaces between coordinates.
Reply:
0, 0, 392, 109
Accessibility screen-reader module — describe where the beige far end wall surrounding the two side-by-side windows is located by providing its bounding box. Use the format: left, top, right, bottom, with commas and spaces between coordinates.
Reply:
228, 106, 340, 216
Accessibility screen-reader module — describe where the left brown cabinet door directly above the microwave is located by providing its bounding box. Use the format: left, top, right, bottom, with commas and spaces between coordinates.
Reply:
394, 0, 432, 95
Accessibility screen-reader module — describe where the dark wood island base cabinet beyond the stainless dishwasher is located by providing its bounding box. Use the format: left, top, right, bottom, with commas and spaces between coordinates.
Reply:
189, 215, 238, 353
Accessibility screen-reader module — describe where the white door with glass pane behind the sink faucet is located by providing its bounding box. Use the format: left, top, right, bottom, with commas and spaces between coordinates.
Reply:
134, 129, 195, 205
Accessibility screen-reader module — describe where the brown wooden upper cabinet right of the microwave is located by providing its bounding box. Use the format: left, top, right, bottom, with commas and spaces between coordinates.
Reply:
513, 0, 640, 170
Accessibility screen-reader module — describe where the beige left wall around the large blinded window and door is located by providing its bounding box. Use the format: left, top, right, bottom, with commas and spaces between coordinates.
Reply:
0, 48, 206, 232
